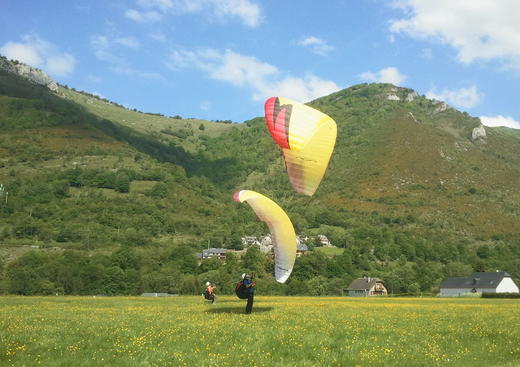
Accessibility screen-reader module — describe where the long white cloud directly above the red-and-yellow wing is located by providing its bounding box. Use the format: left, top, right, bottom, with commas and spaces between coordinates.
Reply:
167, 49, 340, 102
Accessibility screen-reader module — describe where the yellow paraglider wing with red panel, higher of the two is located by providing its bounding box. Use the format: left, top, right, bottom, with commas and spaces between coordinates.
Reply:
265, 97, 337, 196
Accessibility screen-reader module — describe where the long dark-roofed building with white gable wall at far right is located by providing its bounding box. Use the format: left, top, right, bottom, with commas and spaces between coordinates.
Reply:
440, 271, 519, 297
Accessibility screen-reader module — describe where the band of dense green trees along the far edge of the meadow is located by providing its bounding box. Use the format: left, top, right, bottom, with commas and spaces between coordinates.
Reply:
0, 237, 518, 296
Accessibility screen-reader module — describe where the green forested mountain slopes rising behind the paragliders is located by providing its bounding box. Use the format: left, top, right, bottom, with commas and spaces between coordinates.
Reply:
0, 59, 520, 294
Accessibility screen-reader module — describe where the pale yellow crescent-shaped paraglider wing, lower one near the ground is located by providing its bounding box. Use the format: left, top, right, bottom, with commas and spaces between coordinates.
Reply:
233, 190, 296, 283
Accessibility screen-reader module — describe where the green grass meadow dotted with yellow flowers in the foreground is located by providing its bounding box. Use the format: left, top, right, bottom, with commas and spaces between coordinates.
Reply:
0, 295, 520, 367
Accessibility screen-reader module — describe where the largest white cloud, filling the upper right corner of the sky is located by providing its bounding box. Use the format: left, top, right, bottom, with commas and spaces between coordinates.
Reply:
390, 0, 520, 70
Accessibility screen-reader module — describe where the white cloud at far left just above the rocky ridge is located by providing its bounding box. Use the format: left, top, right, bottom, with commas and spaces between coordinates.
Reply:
0, 35, 76, 76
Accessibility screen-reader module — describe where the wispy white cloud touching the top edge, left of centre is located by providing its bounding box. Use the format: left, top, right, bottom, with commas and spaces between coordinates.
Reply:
125, 0, 262, 28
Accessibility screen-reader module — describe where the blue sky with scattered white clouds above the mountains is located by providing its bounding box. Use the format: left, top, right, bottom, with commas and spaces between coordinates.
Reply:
0, 0, 520, 129
